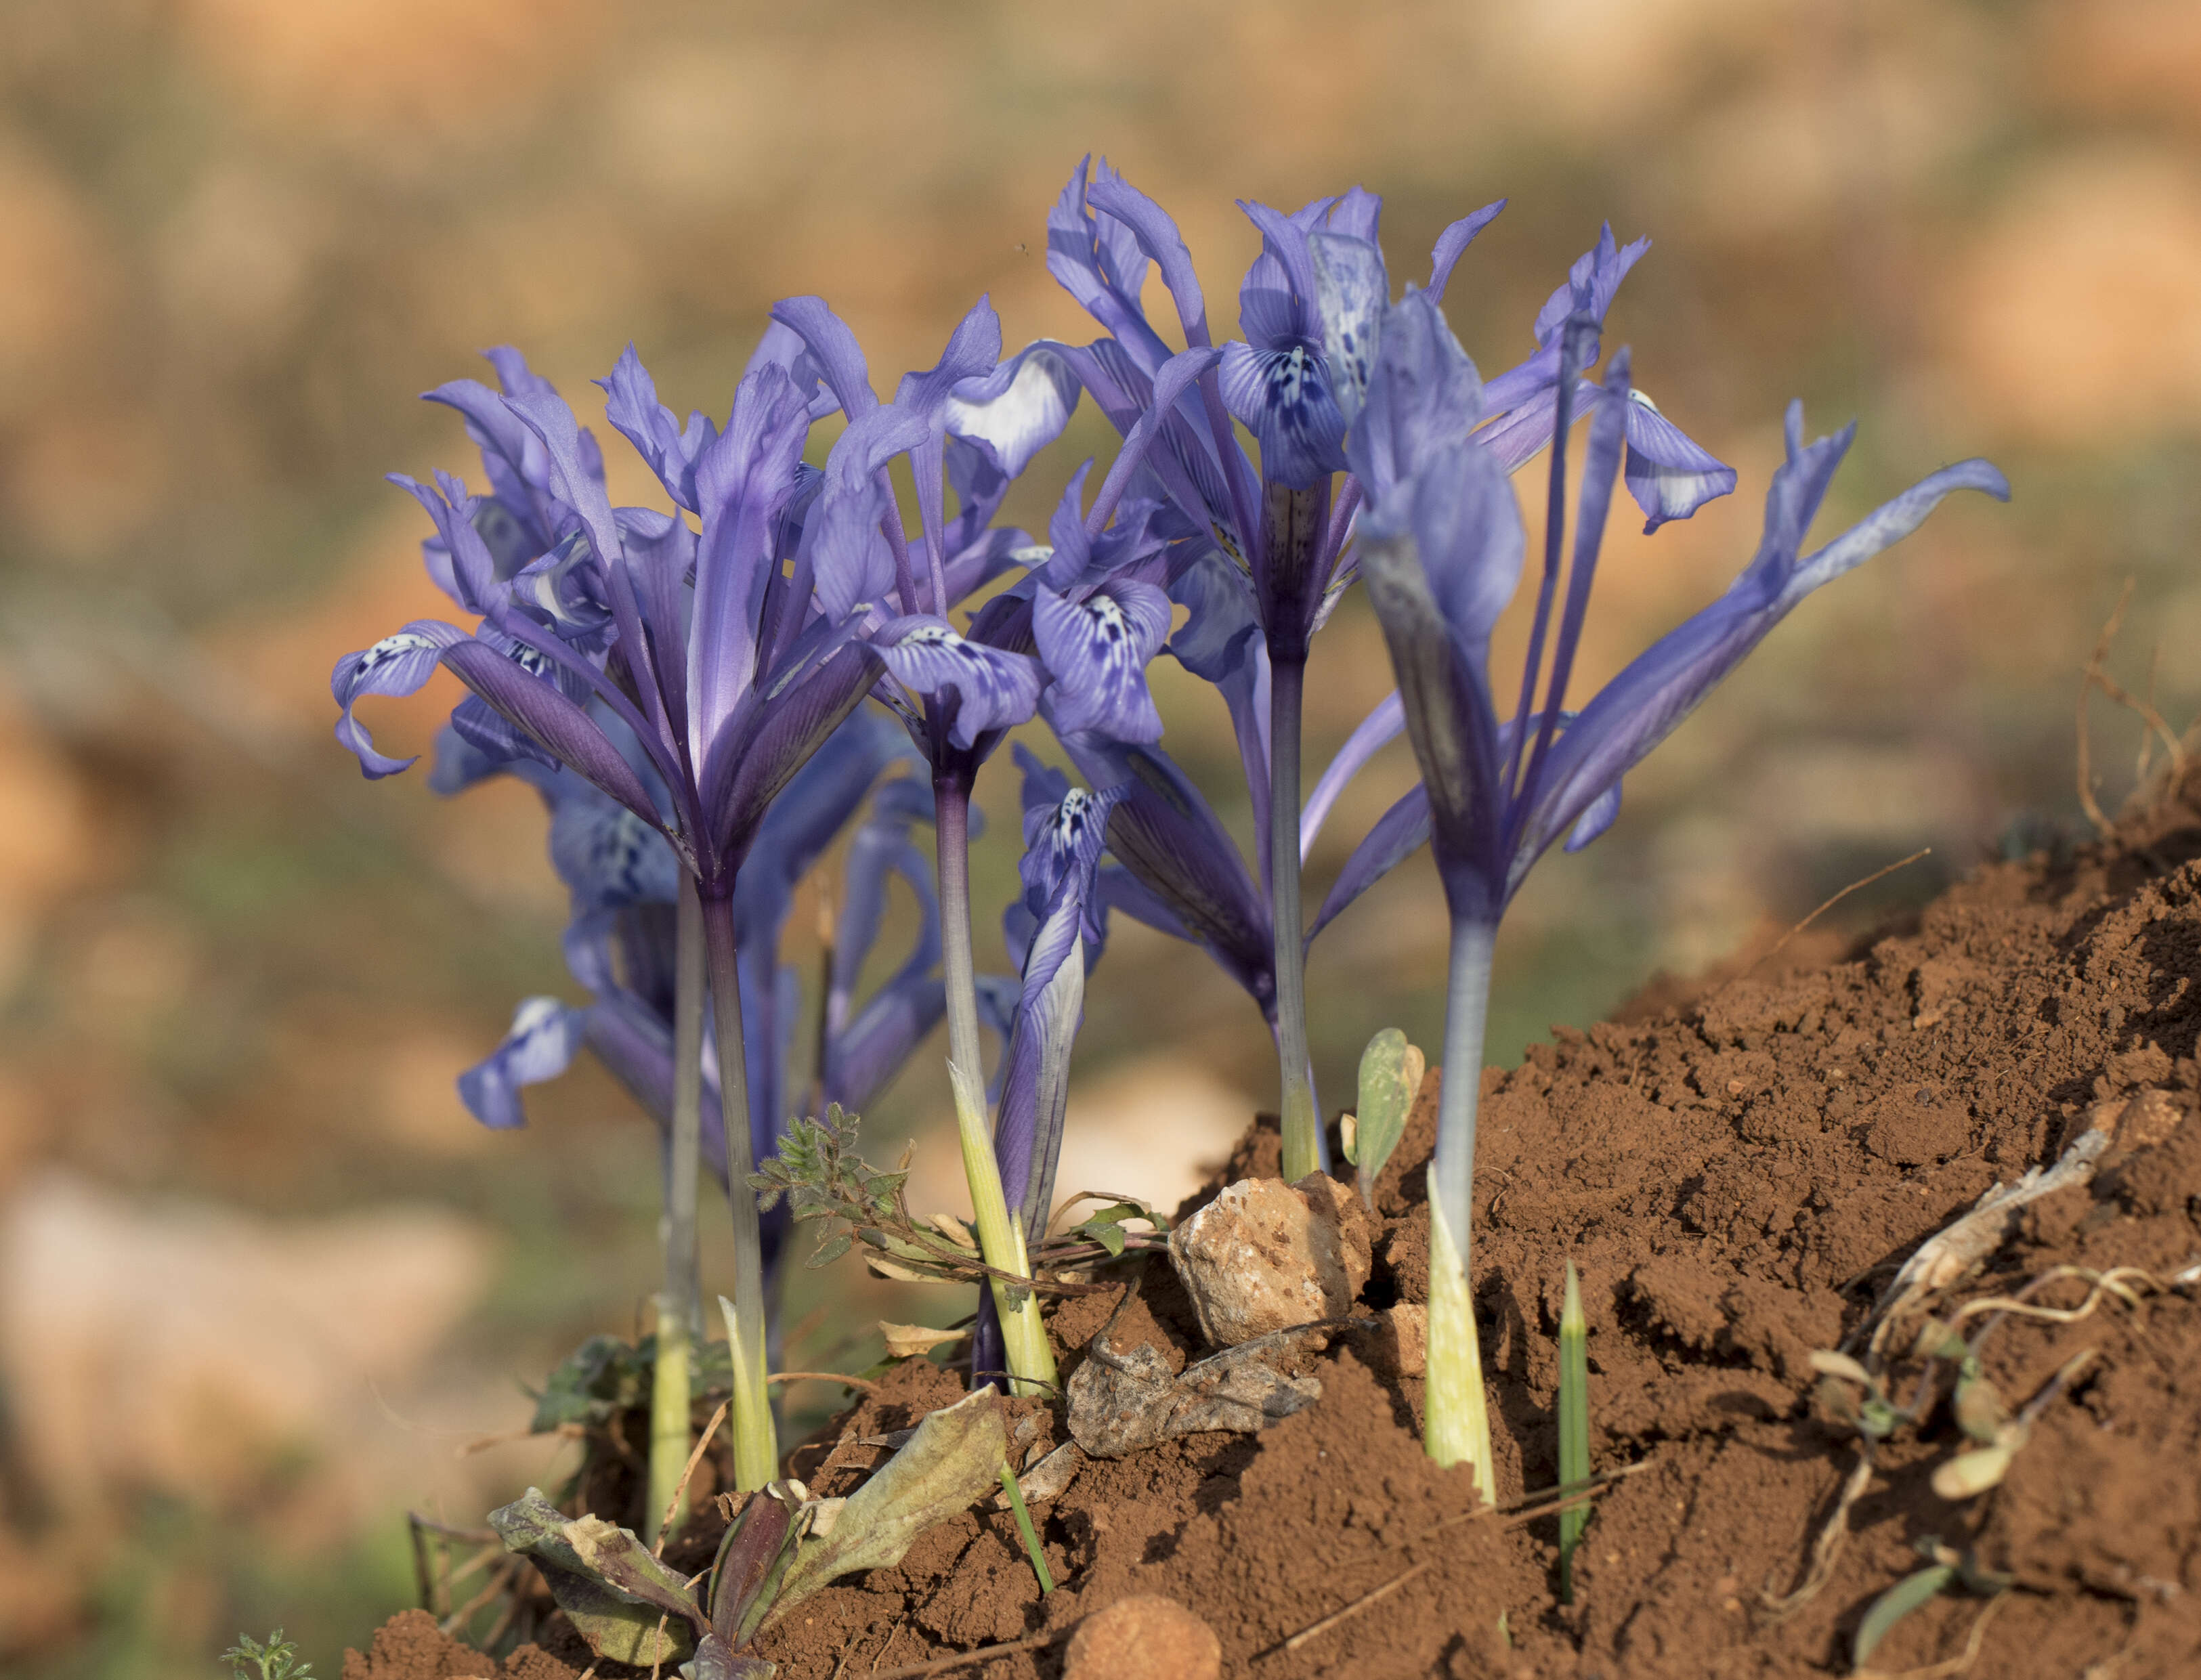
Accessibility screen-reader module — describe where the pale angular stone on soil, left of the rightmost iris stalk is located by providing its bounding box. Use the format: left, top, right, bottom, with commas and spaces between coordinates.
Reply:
1169, 1173, 1369, 1348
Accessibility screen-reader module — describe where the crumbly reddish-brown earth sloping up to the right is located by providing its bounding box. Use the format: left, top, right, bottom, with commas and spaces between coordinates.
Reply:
343, 788, 2201, 1680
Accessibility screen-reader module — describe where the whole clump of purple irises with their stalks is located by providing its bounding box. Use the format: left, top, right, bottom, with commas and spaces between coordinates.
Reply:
333, 147, 2007, 1603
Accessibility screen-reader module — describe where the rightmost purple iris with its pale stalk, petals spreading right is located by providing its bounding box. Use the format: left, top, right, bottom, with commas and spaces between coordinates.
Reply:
1347, 282, 2009, 1462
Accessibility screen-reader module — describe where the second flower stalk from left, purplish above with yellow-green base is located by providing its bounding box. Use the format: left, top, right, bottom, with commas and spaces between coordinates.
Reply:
704, 899, 779, 1511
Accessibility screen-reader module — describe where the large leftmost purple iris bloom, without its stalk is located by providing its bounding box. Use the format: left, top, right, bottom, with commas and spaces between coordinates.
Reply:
333, 337, 876, 903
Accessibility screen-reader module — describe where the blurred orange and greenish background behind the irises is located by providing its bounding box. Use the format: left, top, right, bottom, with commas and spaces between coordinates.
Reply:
0, 0, 2201, 1680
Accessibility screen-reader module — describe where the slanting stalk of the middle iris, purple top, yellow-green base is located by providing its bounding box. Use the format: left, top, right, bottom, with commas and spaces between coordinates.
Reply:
933, 773, 1056, 1394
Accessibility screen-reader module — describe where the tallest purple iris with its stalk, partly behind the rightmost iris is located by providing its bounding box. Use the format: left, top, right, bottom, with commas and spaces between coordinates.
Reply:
1030, 160, 1734, 1176
